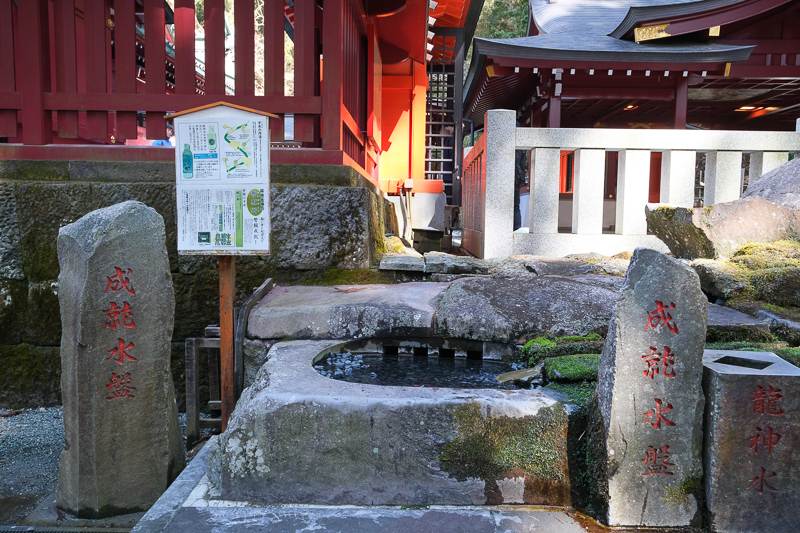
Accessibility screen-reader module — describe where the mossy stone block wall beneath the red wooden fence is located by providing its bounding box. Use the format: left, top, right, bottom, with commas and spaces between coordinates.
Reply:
0, 161, 391, 408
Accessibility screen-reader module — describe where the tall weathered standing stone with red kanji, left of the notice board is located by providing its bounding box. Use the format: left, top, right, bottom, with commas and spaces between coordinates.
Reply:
57, 201, 185, 518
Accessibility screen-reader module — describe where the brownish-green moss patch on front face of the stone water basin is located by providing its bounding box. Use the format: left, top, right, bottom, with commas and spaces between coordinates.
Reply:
439, 402, 568, 482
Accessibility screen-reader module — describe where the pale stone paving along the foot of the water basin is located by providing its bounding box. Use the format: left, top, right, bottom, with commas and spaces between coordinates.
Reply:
131, 437, 585, 533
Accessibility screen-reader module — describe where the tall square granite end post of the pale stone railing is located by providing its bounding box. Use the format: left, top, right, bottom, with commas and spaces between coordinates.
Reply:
483, 109, 517, 259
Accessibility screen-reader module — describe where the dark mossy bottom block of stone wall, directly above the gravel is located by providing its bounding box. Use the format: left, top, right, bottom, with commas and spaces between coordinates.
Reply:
0, 344, 61, 408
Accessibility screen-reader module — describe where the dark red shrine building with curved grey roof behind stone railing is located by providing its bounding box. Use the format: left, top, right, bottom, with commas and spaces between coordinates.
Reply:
464, 0, 800, 131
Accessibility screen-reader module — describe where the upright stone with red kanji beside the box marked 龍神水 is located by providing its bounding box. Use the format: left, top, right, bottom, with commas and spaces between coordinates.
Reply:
598, 248, 708, 526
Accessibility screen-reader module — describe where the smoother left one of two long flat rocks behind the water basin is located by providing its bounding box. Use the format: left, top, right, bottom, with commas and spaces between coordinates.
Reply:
247, 283, 447, 339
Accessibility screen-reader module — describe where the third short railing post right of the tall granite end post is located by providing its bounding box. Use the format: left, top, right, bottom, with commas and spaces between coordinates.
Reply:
615, 150, 650, 235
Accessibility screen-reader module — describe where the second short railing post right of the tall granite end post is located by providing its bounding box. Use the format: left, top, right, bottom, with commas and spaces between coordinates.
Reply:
572, 149, 606, 235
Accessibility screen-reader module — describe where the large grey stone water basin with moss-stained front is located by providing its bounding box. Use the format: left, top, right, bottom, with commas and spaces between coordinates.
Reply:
208, 340, 571, 505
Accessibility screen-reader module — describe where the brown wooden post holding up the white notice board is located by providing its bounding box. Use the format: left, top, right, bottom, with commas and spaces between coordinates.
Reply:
219, 255, 236, 431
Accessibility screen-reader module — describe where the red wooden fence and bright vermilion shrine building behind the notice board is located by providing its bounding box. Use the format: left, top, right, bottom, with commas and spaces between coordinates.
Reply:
0, 0, 483, 205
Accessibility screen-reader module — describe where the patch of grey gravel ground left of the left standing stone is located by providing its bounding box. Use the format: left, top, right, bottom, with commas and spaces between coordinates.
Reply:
0, 407, 64, 525
